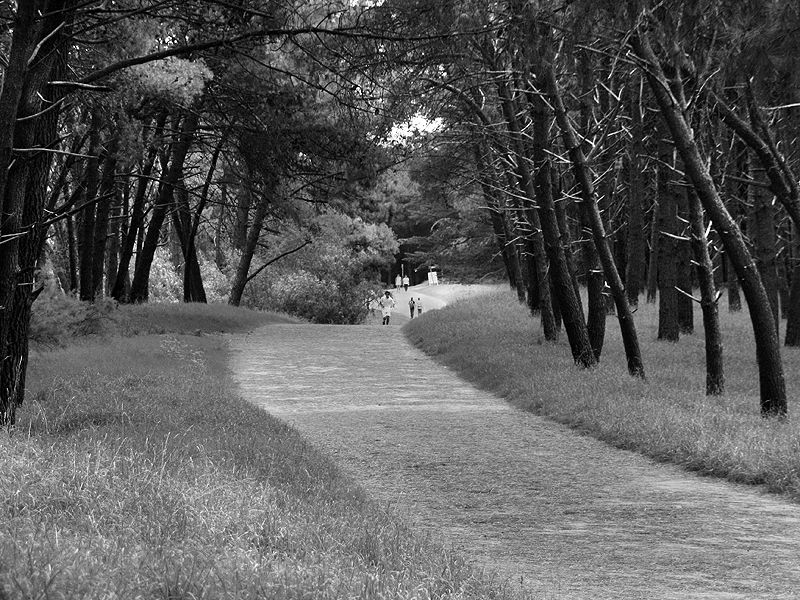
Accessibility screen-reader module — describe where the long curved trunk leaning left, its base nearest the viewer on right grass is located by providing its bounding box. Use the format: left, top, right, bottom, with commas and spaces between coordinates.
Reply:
630, 32, 787, 416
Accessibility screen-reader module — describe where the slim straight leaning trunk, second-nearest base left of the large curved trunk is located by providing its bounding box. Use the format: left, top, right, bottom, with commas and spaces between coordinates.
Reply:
544, 64, 644, 378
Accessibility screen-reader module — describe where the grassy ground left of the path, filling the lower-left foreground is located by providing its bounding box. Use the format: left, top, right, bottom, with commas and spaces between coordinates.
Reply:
0, 301, 505, 600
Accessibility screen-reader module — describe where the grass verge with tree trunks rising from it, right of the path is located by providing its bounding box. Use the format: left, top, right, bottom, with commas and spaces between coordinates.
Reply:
404, 291, 800, 500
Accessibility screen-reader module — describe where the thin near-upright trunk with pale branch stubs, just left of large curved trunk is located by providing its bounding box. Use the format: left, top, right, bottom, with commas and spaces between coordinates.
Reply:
688, 190, 725, 396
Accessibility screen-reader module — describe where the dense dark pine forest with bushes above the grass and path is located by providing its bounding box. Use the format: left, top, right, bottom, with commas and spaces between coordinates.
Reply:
0, 0, 800, 423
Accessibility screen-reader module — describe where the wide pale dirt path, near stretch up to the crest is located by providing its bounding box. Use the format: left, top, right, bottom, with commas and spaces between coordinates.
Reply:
227, 305, 800, 600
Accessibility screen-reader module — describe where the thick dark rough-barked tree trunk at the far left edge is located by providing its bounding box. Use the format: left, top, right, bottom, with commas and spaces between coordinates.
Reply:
0, 1, 69, 425
